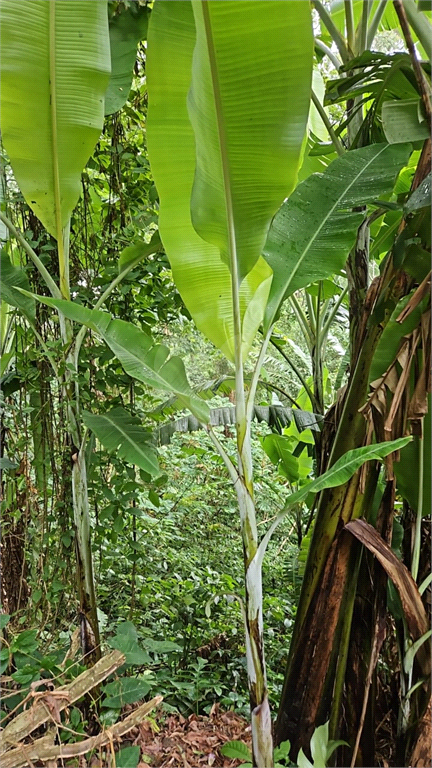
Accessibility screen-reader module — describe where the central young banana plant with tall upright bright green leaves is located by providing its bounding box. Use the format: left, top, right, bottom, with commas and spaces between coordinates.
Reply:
143, 0, 416, 766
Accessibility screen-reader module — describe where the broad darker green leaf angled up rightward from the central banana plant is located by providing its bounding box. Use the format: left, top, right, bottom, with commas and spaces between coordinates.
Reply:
264, 144, 411, 328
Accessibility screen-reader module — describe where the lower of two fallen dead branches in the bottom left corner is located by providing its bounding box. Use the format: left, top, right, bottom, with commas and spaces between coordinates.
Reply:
2, 696, 163, 768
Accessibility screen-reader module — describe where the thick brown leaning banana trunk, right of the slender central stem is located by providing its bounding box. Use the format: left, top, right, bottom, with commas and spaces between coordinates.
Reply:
276, 141, 430, 758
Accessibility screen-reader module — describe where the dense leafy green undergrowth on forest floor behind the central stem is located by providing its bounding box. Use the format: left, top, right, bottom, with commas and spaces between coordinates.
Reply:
2, 412, 301, 729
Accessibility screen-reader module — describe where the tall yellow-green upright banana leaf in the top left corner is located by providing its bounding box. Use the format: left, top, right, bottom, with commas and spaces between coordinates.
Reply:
0, 0, 110, 240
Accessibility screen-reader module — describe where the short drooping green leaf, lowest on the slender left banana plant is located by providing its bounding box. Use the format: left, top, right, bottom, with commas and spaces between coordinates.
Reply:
83, 407, 160, 477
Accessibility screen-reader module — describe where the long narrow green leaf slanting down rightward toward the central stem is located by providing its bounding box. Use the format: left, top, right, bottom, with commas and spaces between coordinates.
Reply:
26, 294, 209, 423
